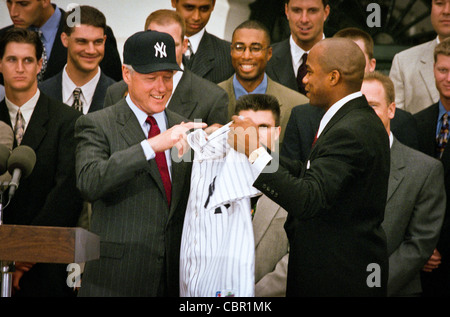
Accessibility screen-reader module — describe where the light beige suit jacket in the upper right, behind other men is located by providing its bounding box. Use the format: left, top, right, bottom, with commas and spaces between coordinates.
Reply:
389, 38, 439, 114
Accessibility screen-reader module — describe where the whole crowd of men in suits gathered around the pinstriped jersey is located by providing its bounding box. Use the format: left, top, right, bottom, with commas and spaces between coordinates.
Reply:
0, 0, 450, 297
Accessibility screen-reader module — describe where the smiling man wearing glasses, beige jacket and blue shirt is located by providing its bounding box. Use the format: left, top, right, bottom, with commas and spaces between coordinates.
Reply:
219, 20, 308, 144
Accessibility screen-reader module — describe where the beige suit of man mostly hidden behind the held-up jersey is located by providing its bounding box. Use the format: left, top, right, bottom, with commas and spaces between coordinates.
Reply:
253, 195, 289, 297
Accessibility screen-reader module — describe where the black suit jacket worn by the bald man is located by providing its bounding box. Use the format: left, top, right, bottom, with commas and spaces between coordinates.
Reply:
254, 97, 390, 296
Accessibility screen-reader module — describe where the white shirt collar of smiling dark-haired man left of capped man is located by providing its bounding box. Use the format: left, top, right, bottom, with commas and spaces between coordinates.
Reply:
62, 64, 101, 114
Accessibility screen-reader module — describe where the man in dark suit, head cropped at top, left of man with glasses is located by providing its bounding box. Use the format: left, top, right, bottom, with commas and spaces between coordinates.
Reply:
171, 0, 234, 84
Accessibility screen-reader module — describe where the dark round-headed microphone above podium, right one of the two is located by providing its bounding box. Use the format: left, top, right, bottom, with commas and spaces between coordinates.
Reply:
8, 145, 36, 199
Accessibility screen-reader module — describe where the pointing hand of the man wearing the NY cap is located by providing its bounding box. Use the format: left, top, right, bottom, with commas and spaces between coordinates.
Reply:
148, 122, 207, 157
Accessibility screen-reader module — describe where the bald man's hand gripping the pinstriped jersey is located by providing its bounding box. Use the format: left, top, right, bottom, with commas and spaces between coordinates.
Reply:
228, 116, 260, 157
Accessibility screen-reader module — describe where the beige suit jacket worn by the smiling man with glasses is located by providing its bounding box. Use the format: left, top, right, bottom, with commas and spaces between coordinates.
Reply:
218, 75, 309, 143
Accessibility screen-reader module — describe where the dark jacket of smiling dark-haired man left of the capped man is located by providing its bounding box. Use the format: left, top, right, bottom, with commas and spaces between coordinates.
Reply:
39, 71, 115, 112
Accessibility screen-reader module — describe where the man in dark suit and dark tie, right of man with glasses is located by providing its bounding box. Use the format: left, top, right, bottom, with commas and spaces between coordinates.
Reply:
266, 0, 330, 94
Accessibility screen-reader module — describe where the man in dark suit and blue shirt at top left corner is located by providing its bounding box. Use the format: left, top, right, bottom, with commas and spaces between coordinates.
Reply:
0, 0, 122, 81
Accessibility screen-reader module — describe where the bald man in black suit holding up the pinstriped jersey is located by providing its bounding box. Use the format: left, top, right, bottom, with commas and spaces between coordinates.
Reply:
228, 38, 390, 296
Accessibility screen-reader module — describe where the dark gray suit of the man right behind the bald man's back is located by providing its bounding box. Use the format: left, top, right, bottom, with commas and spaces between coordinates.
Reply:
382, 138, 446, 296
